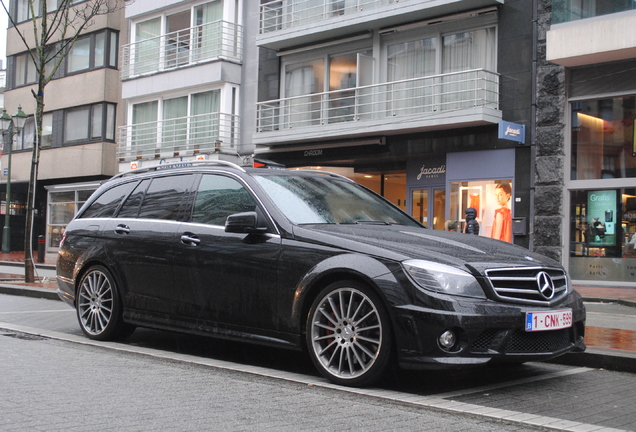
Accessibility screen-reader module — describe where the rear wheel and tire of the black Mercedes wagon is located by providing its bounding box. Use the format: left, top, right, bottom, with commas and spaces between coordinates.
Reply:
76, 266, 135, 341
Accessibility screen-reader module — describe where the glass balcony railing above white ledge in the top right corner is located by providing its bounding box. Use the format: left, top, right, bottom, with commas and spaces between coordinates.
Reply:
552, 0, 636, 24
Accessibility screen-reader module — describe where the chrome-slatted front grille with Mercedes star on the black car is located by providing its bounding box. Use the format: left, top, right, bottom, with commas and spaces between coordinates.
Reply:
485, 267, 568, 305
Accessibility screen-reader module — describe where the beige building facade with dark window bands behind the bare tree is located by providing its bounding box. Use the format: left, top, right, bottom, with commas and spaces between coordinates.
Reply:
0, 0, 127, 252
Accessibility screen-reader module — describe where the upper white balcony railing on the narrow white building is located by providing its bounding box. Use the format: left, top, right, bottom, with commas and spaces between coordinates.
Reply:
121, 21, 243, 80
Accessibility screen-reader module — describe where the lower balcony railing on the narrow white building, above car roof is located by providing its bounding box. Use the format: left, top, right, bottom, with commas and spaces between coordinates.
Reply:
117, 112, 239, 162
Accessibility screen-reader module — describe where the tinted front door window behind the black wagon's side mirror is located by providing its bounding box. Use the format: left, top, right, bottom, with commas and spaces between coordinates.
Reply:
192, 175, 256, 225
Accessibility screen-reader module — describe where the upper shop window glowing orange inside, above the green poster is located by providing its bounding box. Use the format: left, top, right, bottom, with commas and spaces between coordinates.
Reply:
571, 96, 636, 180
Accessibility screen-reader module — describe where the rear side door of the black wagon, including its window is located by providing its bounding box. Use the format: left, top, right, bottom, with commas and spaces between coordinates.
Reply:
104, 174, 195, 314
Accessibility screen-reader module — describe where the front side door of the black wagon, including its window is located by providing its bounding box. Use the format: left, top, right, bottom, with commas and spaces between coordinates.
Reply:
174, 174, 280, 329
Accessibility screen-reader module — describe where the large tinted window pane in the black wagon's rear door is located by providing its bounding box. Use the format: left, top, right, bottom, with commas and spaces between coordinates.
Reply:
139, 175, 193, 220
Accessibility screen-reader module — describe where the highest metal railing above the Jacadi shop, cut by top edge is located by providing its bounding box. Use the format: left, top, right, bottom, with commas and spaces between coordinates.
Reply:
260, 0, 408, 33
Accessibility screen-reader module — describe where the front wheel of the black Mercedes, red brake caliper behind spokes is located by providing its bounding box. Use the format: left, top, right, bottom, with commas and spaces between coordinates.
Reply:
306, 281, 392, 387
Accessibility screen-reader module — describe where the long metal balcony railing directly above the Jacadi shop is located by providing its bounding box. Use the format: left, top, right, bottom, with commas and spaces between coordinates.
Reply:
257, 69, 499, 132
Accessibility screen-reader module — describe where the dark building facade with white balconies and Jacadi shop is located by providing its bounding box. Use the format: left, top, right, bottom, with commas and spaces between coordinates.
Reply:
249, 0, 535, 247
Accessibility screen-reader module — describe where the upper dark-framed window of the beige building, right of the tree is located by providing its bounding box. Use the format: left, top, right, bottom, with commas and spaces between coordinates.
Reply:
66, 30, 117, 73
